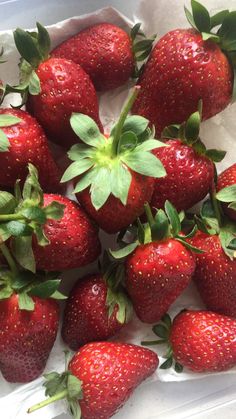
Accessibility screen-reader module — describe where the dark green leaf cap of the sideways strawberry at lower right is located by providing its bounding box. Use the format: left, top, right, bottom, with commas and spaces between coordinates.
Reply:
141, 313, 183, 373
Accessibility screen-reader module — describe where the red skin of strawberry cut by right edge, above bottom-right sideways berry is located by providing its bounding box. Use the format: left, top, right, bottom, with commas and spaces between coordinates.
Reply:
191, 233, 236, 317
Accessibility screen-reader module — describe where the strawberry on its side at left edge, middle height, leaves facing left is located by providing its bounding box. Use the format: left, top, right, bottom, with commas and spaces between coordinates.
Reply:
0, 165, 101, 272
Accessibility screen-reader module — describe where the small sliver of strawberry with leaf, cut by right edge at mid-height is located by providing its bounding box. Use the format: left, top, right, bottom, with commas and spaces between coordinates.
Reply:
217, 163, 236, 221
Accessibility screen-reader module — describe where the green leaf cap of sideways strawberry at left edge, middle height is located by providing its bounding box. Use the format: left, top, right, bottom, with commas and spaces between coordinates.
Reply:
0, 164, 64, 273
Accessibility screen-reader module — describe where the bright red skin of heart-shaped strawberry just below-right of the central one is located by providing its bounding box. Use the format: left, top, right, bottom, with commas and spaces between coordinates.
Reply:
125, 239, 195, 323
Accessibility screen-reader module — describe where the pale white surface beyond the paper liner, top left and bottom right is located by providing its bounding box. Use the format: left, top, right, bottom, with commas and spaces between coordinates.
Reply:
0, 0, 236, 419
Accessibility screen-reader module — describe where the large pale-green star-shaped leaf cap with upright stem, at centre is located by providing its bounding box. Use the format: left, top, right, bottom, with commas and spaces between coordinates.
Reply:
61, 86, 166, 210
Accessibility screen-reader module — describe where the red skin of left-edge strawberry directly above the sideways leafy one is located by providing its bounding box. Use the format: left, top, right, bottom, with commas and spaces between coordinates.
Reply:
0, 108, 61, 192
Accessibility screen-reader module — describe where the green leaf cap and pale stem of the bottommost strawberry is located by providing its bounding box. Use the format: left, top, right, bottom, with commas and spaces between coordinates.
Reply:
27, 351, 83, 419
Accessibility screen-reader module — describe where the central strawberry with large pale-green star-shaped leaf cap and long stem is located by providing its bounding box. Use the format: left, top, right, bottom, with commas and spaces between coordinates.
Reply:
62, 87, 165, 233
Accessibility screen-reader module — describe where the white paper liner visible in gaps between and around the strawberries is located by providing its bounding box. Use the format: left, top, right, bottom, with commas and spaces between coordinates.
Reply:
0, 0, 236, 419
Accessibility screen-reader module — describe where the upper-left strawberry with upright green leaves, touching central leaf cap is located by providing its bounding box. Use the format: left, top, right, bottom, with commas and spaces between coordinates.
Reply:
5, 23, 100, 148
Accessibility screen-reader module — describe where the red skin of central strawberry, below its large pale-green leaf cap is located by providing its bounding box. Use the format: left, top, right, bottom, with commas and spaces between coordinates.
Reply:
76, 172, 154, 233
